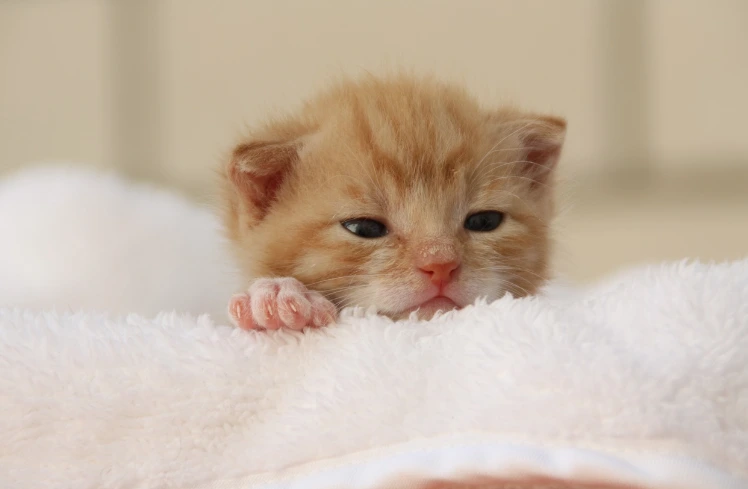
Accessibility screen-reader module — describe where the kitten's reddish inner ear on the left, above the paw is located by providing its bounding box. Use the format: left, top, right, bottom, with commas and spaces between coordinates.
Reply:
227, 141, 300, 221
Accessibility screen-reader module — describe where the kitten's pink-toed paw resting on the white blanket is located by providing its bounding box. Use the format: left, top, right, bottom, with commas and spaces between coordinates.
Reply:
229, 278, 338, 330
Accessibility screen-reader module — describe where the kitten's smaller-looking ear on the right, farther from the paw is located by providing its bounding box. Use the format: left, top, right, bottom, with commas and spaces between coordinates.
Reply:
514, 116, 566, 188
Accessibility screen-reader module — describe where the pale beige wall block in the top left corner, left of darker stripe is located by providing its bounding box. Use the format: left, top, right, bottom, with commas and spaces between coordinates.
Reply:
0, 0, 114, 170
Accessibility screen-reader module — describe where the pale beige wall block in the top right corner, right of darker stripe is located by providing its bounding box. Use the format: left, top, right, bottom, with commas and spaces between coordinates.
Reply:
649, 0, 748, 169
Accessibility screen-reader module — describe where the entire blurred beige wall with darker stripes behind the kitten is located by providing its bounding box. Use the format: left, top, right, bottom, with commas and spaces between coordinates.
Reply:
0, 0, 748, 281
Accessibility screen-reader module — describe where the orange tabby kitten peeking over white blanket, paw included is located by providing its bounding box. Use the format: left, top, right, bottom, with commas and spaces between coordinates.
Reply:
222, 76, 566, 330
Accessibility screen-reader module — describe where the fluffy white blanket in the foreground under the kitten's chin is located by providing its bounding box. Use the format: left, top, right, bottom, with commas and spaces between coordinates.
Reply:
0, 260, 748, 489
